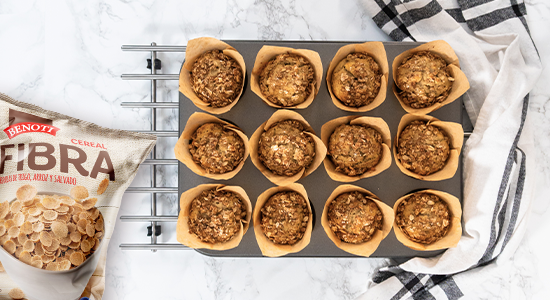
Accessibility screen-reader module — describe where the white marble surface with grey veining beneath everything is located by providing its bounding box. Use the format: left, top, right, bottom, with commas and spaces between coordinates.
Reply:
0, 0, 550, 300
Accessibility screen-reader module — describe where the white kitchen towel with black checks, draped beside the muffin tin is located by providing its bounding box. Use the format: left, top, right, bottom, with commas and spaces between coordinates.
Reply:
359, 0, 542, 299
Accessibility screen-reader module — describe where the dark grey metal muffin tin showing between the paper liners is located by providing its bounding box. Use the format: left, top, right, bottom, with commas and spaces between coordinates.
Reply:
178, 41, 467, 258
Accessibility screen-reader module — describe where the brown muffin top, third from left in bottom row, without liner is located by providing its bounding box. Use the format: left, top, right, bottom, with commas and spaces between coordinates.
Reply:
328, 191, 383, 244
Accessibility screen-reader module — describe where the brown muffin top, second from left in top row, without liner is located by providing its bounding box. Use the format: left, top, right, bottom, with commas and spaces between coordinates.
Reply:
260, 53, 316, 107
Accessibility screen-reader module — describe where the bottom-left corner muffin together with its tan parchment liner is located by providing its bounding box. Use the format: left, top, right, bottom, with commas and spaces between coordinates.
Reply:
176, 184, 252, 250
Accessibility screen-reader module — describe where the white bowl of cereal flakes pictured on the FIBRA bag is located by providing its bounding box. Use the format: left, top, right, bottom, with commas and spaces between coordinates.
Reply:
0, 185, 105, 300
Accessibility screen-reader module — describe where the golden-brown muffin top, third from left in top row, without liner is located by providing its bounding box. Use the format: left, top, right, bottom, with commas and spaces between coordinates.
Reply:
331, 52, 382, 107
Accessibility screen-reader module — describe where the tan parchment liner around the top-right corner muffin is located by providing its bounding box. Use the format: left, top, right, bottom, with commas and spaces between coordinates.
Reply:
392, 40, 470, 115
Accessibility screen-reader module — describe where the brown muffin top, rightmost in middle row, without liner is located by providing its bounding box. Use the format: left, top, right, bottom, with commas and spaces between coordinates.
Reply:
396, 120, 450, 176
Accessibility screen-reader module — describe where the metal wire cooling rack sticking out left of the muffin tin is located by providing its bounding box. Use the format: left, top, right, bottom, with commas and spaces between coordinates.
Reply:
120, 42, 189, 252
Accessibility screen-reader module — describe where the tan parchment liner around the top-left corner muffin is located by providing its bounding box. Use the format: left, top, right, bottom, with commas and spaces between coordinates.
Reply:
179, 37, 246, 115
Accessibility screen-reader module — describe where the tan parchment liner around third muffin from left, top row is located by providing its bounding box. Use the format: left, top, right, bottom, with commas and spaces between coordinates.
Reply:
327, 42, 389, 112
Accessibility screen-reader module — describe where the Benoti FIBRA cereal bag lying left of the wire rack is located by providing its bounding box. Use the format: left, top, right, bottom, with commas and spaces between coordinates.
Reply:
0, 94, 156, 300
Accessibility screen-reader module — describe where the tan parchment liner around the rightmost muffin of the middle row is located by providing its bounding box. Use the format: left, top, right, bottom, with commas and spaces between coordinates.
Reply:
393, 114, 464, 181
